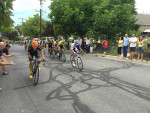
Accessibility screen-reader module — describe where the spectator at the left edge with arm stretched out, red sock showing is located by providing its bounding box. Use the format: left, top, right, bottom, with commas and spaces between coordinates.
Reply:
0, 42, 14, 75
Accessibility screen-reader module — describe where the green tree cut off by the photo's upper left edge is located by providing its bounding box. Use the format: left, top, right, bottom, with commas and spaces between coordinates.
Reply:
0, 0, 14, 32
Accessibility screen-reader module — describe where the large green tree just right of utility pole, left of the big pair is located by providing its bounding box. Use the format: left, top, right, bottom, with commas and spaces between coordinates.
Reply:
49, 0, 94, 35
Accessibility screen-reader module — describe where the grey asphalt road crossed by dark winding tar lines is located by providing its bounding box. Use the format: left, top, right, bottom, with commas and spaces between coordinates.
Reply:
0, 45, 150, 113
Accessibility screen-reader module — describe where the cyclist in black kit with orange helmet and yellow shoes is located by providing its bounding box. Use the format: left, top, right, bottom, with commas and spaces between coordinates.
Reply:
28, 41, 45, 78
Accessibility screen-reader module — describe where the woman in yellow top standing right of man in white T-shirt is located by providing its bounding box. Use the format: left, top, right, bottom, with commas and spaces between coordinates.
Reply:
137, 36, 144, 61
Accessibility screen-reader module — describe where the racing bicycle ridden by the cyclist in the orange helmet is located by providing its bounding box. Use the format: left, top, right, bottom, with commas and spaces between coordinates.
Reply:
32, 57, 45, 85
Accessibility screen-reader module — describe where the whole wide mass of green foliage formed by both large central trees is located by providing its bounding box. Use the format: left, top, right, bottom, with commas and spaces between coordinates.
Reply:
49, 0, 138, 40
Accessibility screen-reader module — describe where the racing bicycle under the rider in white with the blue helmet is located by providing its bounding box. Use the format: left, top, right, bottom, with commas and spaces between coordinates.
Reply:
70, 53, 83, 71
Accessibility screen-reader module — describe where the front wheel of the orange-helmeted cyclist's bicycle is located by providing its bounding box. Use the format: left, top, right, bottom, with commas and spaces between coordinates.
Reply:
33, 65, 39, 85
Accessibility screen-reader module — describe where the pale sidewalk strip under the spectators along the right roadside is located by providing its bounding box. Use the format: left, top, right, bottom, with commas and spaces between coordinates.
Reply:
91, 53, 150, 66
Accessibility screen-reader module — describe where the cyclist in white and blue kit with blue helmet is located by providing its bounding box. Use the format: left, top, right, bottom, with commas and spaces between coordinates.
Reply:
71, 40, 82, 66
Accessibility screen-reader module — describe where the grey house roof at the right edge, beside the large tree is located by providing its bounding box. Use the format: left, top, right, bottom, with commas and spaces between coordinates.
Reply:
136, 14, 150, 25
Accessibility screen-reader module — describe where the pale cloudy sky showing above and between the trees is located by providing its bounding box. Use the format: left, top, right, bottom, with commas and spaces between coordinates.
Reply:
12, 0, 150, 25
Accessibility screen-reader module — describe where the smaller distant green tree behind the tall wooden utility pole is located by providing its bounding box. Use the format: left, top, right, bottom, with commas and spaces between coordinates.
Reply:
21, 14, 46, 38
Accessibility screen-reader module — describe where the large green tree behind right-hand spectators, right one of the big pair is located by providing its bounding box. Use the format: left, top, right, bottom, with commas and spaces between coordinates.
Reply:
93, 0, 136, 40
